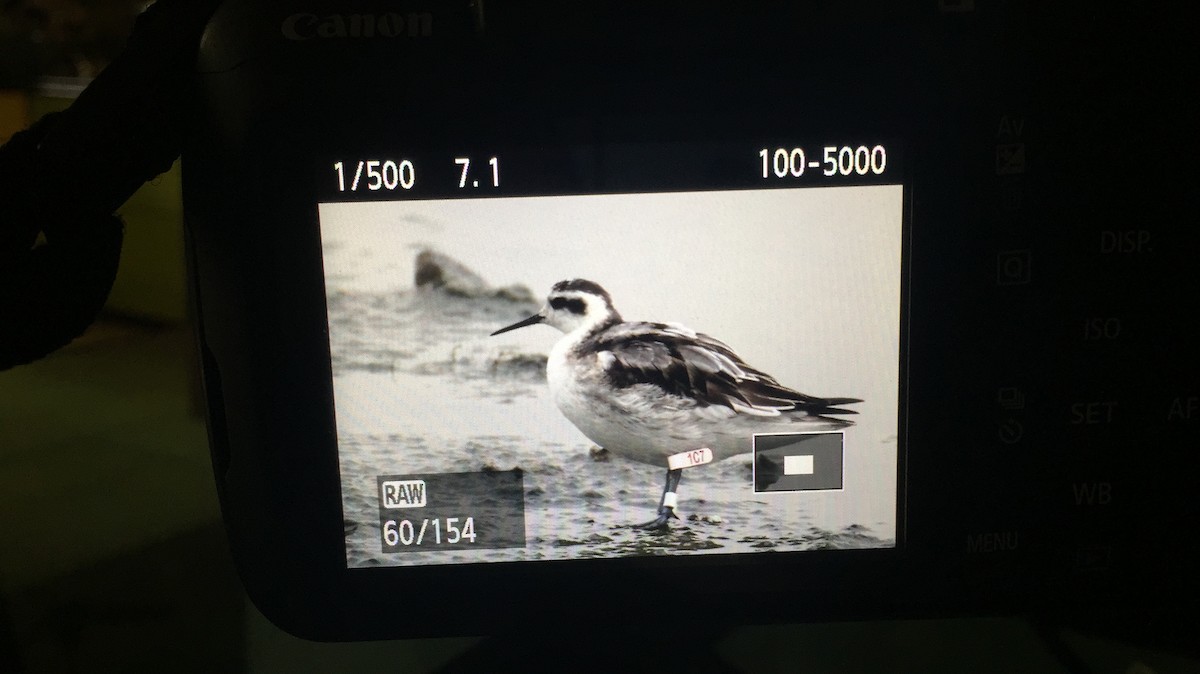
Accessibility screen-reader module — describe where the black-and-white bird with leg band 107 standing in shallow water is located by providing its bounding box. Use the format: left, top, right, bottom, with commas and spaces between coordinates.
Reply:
491, 278, 863, 530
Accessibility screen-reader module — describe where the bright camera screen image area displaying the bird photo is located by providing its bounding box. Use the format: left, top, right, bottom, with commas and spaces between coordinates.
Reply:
318, 146, 905, 568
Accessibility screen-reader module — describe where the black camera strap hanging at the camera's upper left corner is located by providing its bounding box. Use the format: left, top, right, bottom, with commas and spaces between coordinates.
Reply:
0, 0, 220, 371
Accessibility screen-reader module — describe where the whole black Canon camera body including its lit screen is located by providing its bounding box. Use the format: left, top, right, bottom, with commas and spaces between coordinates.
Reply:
184, 1, 1200, 639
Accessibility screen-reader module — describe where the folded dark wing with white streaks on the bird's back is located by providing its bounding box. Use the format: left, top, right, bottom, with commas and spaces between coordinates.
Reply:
589, 323, 862, 416
